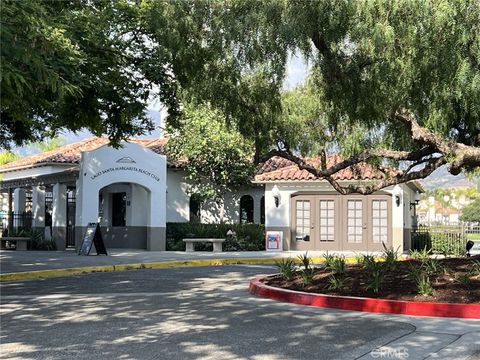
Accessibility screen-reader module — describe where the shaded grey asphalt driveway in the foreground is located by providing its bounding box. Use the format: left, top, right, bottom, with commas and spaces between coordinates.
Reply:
0, 266, 480, 360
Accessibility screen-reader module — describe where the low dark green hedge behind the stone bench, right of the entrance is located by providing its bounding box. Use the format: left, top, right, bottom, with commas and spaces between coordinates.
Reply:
166, 223, 265, 251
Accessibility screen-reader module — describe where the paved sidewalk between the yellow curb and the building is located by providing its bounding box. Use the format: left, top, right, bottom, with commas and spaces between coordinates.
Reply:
0, 249, 380, 274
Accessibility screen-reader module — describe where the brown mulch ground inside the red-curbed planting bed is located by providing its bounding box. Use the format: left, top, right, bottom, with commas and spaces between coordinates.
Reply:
265, 256, 480, 304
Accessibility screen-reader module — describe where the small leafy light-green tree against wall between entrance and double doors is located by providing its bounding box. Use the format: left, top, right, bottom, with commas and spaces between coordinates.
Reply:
167, 106, 254, 204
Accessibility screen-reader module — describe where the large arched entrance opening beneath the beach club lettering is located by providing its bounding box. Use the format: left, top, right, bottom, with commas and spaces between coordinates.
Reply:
98, 182, 150, 249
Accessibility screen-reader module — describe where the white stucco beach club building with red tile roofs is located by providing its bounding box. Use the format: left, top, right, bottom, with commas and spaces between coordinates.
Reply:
0, 138, 422, 251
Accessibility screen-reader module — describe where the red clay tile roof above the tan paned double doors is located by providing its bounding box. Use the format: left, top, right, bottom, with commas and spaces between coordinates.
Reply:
255, 155, 394, 182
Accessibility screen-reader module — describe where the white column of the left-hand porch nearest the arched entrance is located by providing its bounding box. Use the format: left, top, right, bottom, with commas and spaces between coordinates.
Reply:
52, 183, 67, 250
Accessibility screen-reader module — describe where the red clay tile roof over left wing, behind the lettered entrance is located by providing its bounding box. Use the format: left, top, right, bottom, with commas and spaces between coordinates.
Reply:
0, 137, 168, 171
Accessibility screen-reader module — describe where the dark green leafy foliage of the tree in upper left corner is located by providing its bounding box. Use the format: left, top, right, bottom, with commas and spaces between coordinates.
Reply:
0, 0, 155, 147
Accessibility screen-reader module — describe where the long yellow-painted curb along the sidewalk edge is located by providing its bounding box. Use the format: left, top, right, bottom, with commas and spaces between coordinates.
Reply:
0, 257, 355, 282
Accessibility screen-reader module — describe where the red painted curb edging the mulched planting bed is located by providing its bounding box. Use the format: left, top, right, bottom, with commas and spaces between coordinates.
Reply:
249, 276, 480, 319
